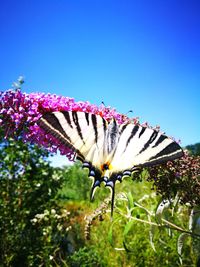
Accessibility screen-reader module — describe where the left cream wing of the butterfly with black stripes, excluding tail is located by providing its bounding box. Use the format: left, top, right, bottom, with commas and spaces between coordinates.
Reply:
38, 111, 108, 168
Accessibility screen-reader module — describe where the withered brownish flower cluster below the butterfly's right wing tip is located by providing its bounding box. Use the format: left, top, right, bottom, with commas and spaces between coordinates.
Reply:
148, 153, 200, 206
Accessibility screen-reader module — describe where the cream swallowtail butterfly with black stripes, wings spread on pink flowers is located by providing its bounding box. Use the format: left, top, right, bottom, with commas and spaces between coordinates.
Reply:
38, 111, 184, 216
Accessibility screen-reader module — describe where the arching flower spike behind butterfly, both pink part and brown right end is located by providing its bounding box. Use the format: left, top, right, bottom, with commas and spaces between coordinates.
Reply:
0, 87, 200, 205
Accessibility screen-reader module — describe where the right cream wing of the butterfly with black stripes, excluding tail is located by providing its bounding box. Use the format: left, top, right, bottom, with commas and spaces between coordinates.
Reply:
111, 123, 183, 172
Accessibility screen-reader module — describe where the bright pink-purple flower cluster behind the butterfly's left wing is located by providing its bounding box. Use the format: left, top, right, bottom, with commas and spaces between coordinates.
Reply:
0, 88, 131, 160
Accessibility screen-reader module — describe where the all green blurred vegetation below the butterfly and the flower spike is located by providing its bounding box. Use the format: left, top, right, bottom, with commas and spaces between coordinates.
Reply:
0, 129, 200, 267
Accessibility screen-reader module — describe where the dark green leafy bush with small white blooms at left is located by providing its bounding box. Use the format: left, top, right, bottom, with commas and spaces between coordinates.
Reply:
0, 136, 68, 266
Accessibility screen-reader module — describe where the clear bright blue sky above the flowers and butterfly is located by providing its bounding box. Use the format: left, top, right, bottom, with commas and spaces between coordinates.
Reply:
0, 0, 200, 165
